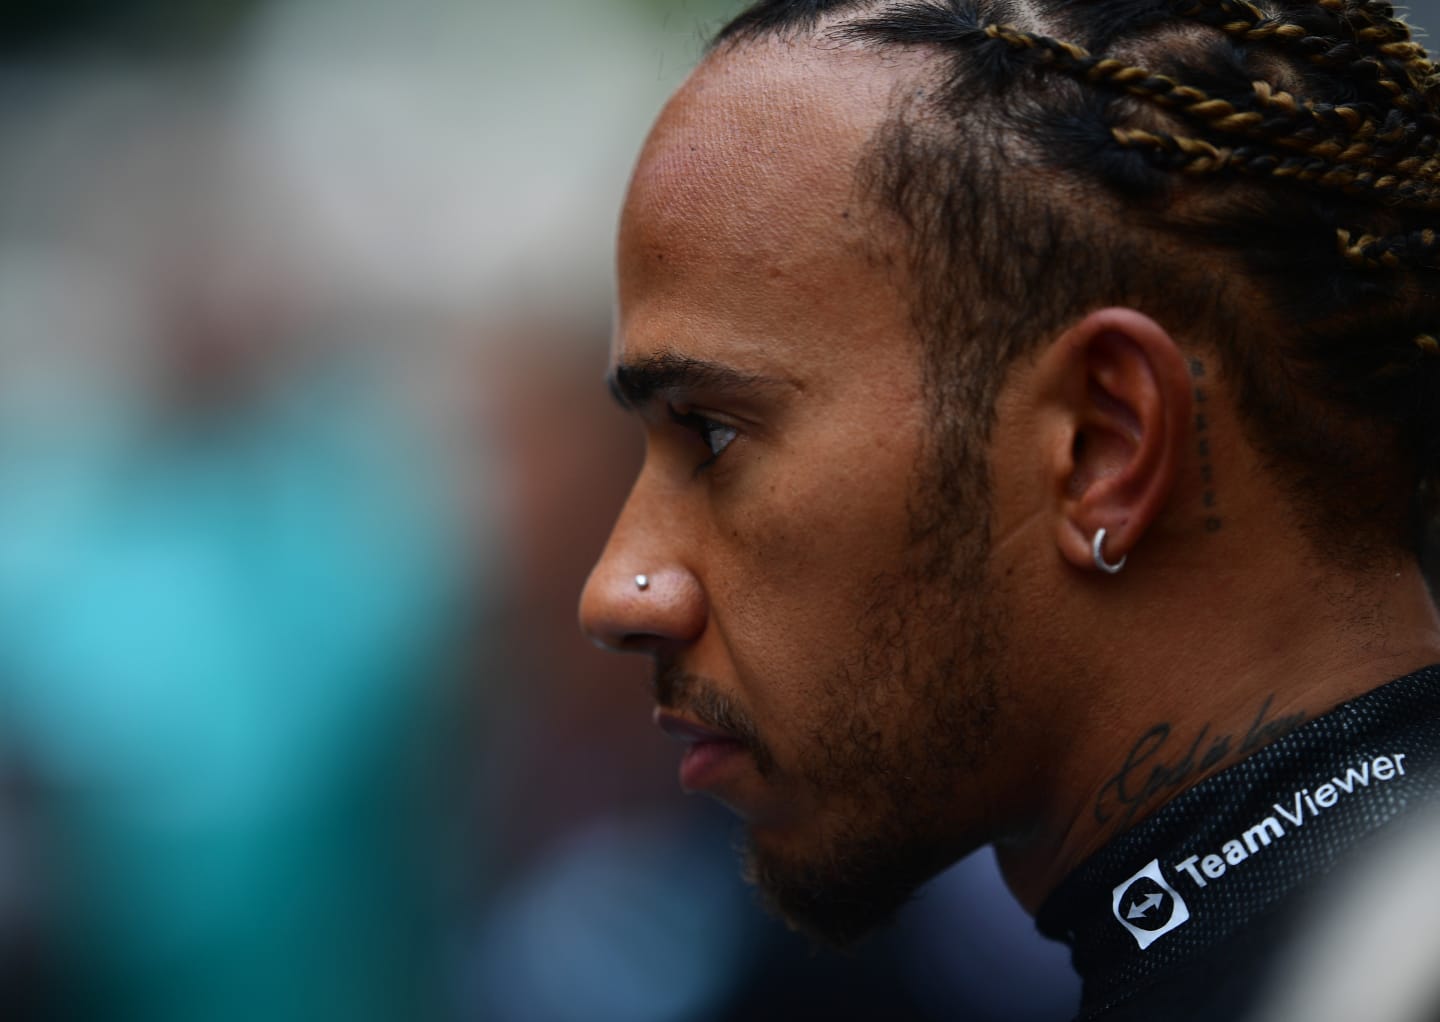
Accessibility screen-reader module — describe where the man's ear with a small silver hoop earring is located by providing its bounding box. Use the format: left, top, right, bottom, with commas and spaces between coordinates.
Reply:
1037, 308, 1192, 571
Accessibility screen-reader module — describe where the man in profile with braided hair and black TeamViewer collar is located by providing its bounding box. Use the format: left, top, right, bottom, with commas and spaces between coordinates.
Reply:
582, 0, 1440, 1018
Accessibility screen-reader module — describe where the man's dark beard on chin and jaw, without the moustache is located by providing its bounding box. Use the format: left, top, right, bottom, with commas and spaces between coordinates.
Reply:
743, 561, 1002, 949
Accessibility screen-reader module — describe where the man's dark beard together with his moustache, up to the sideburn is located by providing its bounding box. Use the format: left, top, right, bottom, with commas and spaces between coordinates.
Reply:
655, 443, 1005, 949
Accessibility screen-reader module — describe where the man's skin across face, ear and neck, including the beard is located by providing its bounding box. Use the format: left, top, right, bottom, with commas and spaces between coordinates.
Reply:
580, 32, 1440, 943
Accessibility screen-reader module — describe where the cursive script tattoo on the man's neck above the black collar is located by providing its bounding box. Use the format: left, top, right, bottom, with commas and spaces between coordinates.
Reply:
1094, 694, 1305, 828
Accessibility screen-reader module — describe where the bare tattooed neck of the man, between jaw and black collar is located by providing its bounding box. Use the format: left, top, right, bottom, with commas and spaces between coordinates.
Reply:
996, 547, 1440, 911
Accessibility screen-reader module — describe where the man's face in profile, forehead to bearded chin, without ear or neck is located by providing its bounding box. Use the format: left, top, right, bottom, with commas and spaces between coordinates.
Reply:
582, 42, 1001, 941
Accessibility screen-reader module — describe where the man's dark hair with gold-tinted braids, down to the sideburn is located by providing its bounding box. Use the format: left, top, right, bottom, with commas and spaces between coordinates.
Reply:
717, 0, 1440, 563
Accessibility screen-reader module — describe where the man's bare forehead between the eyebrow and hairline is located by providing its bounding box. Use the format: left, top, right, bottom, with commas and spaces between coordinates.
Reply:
616, 37, 913, 380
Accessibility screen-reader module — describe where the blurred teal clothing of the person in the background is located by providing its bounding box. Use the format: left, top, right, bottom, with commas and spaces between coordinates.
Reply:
0, 277, 478, 1022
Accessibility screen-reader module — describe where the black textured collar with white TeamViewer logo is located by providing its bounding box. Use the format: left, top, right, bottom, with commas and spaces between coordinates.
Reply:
1037, 666, 1440, 1021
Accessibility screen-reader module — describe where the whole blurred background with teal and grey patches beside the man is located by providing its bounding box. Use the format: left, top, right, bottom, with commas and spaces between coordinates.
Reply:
0, 0, 1424, 1022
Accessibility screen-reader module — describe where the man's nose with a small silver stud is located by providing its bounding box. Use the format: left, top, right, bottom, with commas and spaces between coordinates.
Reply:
580, 489, 707, 654
